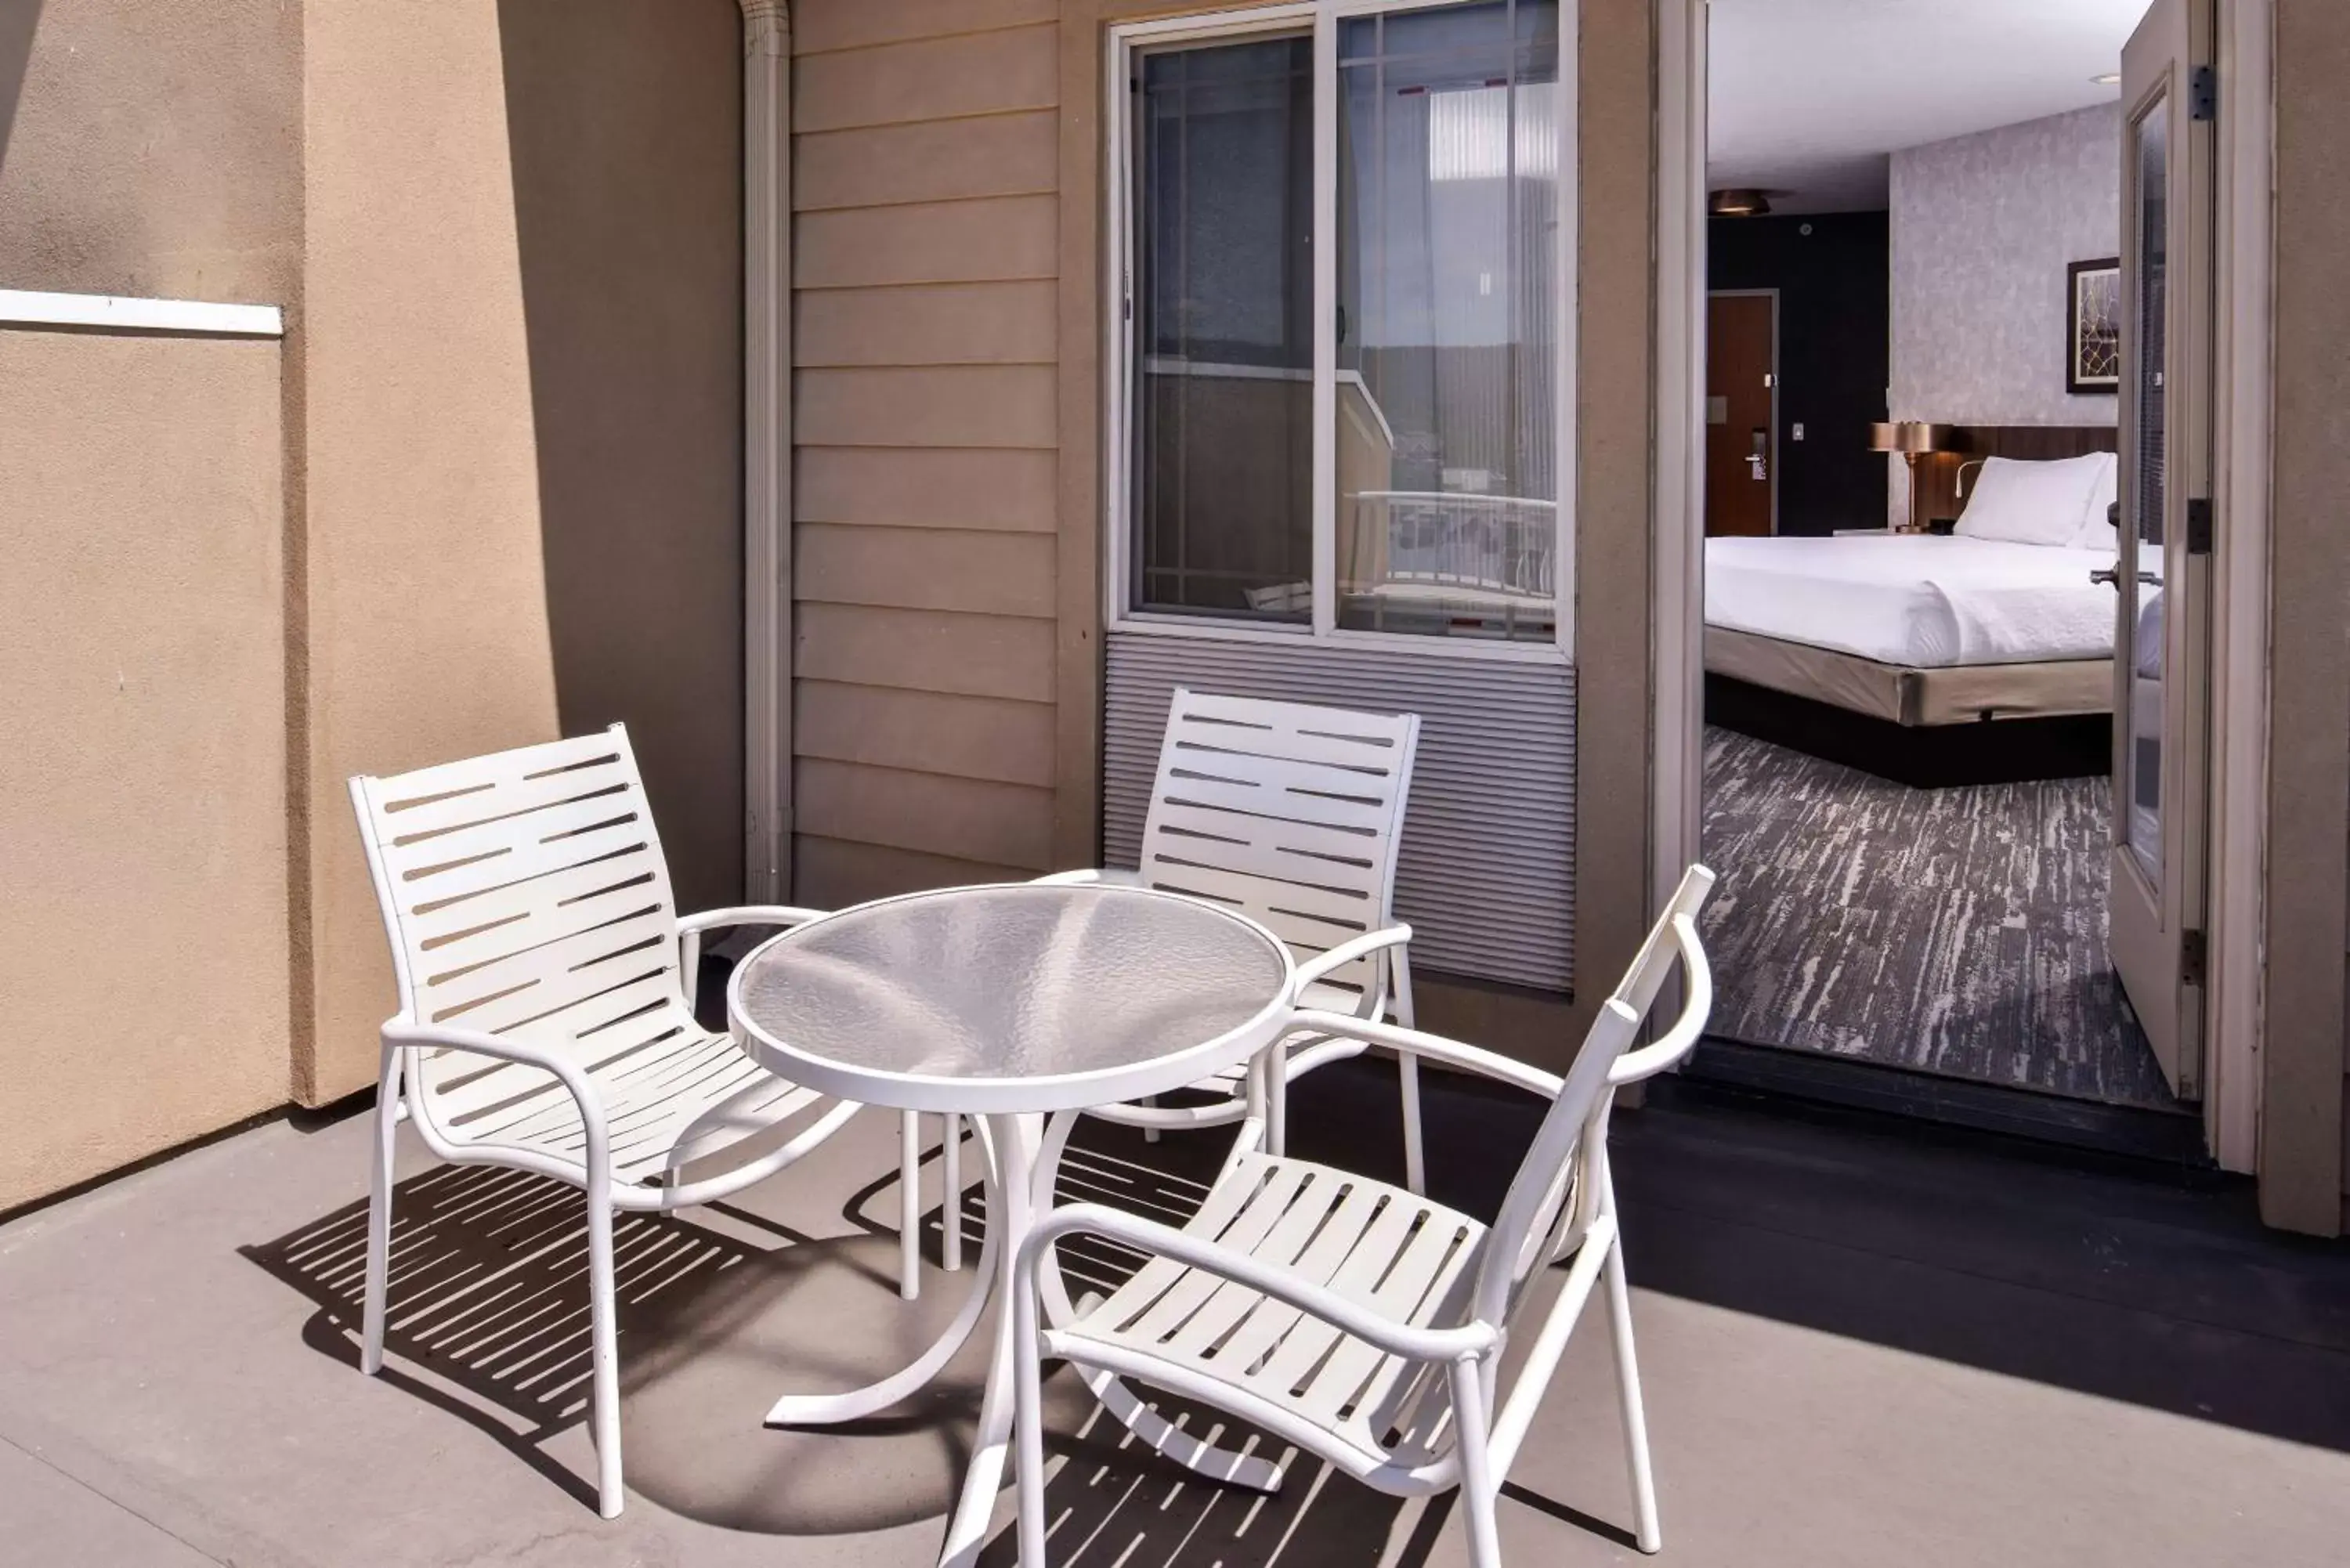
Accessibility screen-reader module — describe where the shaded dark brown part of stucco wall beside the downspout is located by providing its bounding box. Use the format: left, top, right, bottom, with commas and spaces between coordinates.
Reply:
498, 0, 743, 910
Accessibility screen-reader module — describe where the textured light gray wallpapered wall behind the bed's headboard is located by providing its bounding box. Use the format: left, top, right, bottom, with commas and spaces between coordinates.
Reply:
1887, 103, 2122, 524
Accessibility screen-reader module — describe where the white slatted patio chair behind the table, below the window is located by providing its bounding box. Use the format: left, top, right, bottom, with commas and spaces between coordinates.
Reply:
1034, 686, 1422, 1175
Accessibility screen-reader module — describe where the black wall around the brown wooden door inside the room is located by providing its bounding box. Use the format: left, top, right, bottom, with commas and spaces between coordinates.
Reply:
1706, 211, 1892, 533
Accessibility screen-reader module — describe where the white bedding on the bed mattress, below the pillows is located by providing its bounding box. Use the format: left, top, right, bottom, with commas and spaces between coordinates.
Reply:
1706, 533, 2113, 670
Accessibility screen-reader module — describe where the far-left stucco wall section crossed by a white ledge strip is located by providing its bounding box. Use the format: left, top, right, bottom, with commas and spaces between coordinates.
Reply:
0, 0, 301, 1209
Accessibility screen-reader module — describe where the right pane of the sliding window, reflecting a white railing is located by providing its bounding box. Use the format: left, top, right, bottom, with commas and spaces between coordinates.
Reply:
1337, 0, 1558, 641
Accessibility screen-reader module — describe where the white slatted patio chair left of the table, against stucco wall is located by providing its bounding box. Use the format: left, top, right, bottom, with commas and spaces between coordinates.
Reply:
350, 724, 916, 1519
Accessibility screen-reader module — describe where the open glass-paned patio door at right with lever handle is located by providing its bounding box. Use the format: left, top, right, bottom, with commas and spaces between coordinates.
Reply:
2110, 0, 2214, 1098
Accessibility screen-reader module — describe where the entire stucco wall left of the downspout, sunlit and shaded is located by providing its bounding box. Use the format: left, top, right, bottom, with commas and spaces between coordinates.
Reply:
0, 0, 743, 1189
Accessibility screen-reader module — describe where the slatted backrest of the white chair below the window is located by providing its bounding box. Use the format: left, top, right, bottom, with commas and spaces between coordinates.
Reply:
1140, 686, 1419, 997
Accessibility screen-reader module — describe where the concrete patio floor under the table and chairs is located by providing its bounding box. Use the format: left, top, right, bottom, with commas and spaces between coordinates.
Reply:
0, 1070, 2350, 1568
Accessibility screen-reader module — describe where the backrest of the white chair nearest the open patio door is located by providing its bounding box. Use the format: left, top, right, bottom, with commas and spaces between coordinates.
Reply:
1471, 865, 1713, 1324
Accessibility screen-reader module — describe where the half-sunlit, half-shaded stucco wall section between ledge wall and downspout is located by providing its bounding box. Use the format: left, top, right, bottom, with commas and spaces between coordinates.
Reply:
296, 0, 743, 1103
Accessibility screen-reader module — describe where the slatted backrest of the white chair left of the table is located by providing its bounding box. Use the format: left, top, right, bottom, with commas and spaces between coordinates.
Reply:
350, 724, 693, 1093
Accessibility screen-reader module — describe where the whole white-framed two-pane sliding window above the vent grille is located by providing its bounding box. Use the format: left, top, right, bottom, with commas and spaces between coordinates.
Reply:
1112, 0, 1572, 646
